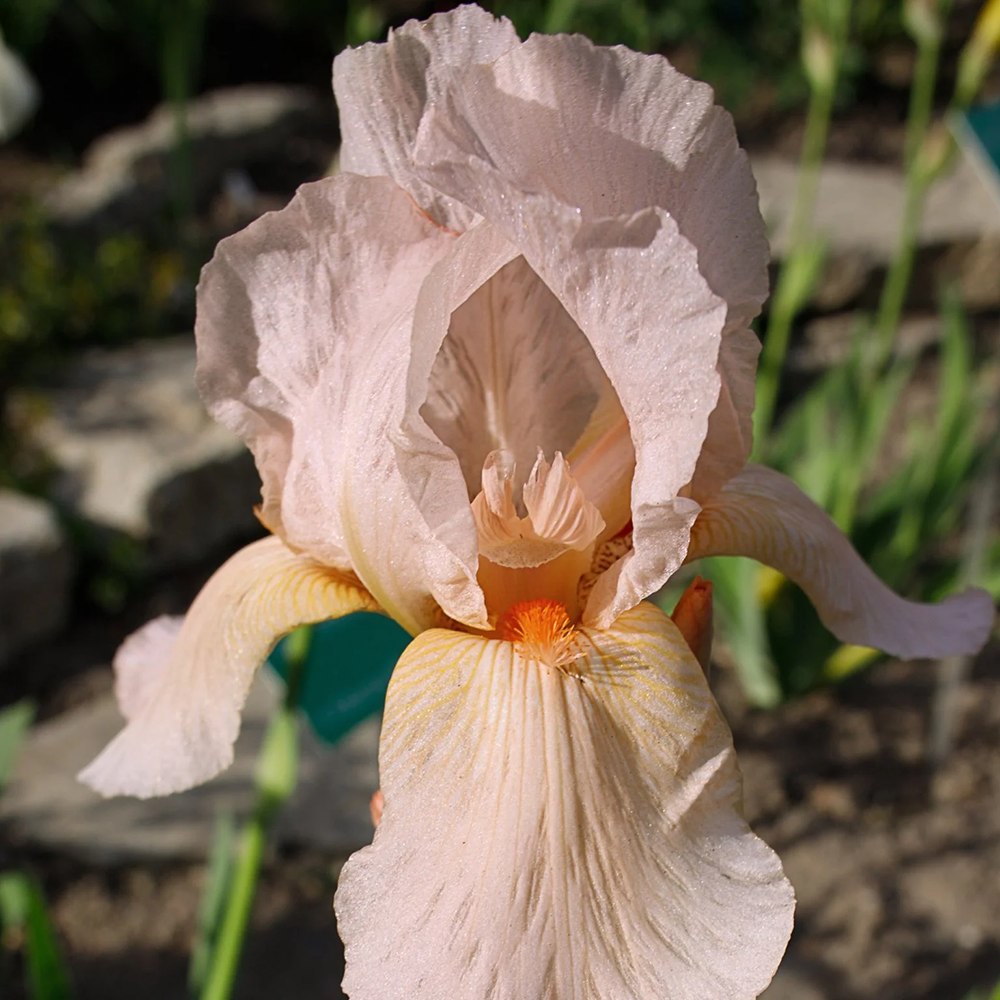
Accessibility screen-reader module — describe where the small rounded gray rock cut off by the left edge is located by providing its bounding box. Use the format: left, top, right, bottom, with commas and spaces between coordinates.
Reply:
0, 490, 73, 665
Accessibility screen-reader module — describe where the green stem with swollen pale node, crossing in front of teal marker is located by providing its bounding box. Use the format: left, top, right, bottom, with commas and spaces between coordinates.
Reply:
201, 628, 312, 1000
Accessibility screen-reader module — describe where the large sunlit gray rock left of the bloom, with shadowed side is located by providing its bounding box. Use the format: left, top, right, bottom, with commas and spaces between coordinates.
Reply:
15, 337, 260, 570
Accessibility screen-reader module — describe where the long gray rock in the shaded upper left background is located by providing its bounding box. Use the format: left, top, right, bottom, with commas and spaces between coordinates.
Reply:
46, 85, 335, 229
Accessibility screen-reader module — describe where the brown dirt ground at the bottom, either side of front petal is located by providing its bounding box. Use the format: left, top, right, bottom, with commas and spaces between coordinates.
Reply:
4, 647, 1000, 1000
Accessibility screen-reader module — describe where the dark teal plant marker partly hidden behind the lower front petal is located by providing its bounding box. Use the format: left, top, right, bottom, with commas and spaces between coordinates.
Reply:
270, 611, 410, 743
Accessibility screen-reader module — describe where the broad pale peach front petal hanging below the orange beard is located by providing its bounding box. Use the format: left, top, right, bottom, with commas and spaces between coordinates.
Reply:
336, 604, 793, 1000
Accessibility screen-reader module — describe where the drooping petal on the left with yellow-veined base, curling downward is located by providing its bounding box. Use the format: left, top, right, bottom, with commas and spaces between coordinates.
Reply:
80, 537, 378, 798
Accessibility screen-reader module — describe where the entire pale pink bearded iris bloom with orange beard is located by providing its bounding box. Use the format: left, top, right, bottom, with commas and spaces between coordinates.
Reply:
84, 7, 992, 1000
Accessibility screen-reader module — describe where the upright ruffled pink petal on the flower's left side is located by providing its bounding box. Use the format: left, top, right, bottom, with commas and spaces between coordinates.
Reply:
197, 168, 492, 631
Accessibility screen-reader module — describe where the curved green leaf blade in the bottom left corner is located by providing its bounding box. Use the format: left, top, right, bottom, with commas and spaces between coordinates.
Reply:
0, 872, 70, 1000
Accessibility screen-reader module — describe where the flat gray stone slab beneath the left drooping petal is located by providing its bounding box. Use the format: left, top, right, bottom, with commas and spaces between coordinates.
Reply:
0, 674, 379, 864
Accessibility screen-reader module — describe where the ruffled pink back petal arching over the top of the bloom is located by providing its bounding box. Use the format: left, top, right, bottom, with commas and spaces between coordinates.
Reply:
335, 7, 768, 498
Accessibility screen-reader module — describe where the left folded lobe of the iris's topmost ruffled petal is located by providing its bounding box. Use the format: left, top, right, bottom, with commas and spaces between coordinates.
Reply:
333, 5, 519, 231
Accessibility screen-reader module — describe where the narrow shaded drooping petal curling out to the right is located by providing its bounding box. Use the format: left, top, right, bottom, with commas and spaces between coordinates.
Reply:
688, 465, 995, 658
